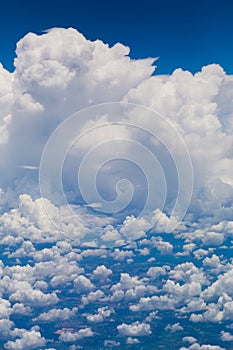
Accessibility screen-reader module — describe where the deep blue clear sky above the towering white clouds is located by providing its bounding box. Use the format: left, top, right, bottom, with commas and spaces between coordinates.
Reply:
0, 0, 233, 74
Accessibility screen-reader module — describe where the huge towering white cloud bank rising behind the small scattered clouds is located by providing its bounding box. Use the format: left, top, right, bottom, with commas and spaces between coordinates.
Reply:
0, 28, 233, 246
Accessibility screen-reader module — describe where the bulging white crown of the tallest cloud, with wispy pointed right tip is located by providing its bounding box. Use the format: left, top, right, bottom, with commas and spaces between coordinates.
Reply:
15, 28, 154, 107
